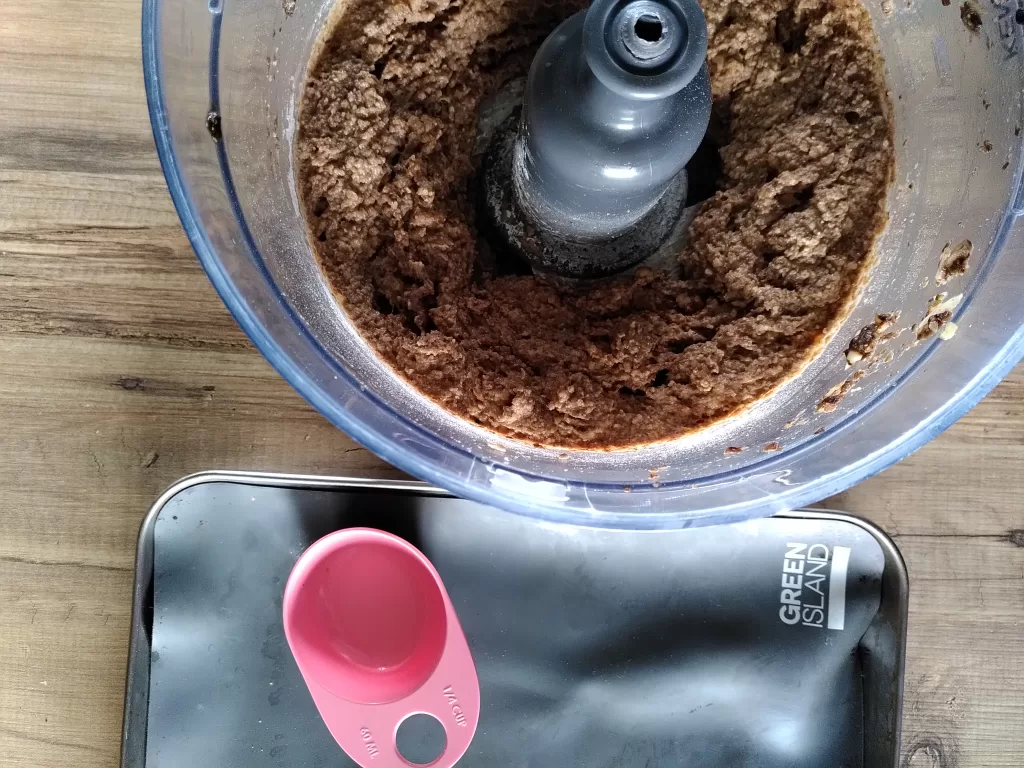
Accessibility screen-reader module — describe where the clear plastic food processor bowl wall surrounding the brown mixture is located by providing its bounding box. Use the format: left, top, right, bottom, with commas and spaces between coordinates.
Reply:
142, 0, 1024, 528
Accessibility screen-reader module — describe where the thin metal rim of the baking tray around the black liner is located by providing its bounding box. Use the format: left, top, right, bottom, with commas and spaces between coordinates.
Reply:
120, 469, 909, 768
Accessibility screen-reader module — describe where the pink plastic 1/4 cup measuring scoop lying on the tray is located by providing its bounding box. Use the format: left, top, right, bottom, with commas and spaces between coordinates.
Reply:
284, 528, 480, 768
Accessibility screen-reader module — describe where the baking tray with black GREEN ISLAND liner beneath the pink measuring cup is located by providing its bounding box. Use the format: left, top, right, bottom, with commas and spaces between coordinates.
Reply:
121, 472, 908, 768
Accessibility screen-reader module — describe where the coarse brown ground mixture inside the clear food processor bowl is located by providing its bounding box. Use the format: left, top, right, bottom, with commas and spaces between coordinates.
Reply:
297, 0, 894, 449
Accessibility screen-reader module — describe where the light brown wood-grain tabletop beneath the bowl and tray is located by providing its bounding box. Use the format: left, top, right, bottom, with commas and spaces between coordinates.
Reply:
0, 0, 1024, 768
